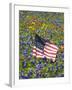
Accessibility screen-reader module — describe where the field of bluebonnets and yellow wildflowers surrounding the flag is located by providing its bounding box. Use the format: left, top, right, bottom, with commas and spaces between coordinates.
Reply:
19, 11, 64, 79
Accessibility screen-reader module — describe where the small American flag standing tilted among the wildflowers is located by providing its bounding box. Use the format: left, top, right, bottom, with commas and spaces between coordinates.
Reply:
32, 34, 58, 62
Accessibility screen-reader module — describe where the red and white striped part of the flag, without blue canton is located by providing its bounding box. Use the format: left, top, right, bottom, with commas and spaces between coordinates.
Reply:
33, 43, 58, 60
